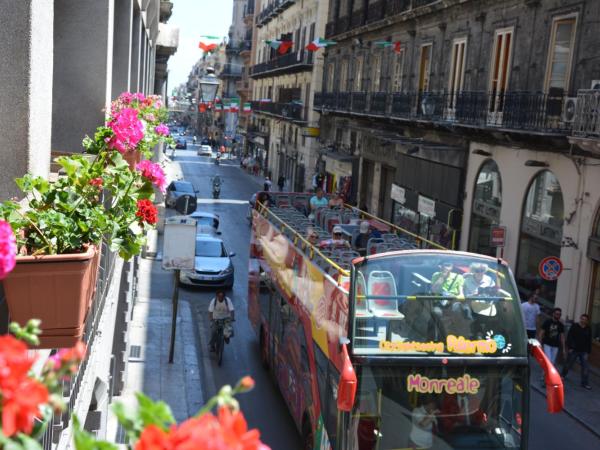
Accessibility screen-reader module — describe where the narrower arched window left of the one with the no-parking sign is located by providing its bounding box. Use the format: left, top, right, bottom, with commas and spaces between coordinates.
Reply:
469, 159, 502, 256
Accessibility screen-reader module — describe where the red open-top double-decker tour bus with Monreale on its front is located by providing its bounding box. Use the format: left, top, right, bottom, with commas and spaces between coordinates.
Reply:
248, 193, 563, 450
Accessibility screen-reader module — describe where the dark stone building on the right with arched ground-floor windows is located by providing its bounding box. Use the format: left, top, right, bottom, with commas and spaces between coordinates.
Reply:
315, 0, 600, 364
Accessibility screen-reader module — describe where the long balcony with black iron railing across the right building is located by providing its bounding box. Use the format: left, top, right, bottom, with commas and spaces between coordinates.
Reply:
314, 91, 572, 137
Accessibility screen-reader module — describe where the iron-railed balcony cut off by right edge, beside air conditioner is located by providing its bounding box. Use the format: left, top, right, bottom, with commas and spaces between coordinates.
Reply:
568, 89, 600, 155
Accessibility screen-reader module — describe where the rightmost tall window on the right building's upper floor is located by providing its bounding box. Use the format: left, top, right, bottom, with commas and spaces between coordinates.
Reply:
545, 17, 576, 91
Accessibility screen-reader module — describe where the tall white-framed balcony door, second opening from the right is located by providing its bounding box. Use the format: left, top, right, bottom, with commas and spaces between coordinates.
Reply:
488, 28, 513, 125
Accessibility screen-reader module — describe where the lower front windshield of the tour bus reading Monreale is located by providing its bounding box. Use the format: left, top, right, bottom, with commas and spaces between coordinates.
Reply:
347, 366, 526, 450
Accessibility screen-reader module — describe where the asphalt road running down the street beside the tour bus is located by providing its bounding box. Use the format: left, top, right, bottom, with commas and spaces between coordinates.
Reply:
169, 139, 600, 450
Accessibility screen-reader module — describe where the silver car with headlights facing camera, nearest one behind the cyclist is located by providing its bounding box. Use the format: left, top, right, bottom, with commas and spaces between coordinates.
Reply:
179, 235, 235, 289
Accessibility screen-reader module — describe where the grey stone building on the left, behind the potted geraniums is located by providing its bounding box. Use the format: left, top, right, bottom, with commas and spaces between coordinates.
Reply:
0, 0, 178, 444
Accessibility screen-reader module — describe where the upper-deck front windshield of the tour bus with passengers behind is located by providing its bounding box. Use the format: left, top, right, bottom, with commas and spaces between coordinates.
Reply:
352, 252, 527, 357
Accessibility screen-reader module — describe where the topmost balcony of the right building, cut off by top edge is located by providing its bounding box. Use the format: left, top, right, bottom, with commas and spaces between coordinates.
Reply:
325, 0, 441, 38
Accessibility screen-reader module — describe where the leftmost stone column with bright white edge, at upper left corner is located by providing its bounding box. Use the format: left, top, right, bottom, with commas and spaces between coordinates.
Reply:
0, 0, 54, 201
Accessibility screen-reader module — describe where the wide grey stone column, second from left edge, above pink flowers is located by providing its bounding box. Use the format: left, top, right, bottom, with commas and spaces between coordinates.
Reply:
52, 0, 114, 152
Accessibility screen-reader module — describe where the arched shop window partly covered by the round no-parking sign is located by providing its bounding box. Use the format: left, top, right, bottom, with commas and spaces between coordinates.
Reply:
517, 170, 564, 307
